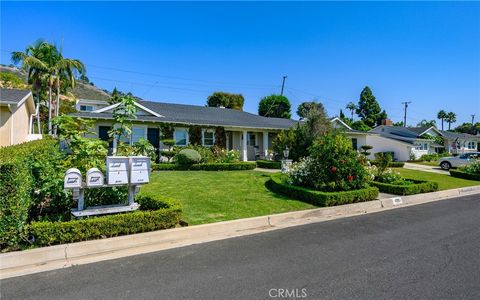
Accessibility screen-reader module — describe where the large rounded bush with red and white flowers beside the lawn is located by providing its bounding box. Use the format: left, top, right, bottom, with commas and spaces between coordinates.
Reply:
288, 134, 369, 192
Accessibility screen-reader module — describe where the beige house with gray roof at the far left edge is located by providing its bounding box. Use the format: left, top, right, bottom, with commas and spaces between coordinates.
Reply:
0, 88, 42, 147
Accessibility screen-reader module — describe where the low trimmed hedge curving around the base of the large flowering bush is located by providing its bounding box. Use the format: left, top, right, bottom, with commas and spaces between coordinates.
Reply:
266, 174, 378, 206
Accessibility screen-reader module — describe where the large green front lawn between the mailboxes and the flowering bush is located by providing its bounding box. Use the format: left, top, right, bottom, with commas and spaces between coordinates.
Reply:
142, 171, 315, 225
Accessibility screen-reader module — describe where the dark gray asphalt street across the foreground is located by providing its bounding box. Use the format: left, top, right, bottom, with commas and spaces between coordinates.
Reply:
0, 195, 480, 300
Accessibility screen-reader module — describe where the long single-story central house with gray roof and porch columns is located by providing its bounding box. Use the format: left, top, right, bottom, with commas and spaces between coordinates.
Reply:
71, 101, 298, 161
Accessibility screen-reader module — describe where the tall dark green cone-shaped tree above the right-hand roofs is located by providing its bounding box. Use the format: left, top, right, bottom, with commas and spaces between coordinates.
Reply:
356, 86, 387, 127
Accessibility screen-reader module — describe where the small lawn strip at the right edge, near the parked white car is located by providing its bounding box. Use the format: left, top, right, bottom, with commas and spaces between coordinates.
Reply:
394, 168, 480, 191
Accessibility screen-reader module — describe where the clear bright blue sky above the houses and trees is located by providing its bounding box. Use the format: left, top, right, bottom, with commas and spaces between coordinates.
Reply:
0, 1, 480, 124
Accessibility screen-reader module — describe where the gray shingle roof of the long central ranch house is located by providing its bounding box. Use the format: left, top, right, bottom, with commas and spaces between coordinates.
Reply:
71, 101, 298, 129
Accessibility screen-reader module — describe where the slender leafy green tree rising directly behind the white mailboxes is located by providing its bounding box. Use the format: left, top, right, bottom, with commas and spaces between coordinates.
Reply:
108, 96, 137, 152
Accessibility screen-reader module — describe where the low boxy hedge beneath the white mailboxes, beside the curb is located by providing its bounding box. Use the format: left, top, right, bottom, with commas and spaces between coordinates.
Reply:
28, 193, 182, 246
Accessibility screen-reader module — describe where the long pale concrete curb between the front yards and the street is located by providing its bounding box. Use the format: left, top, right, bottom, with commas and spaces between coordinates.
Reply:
0, 186, 480, 279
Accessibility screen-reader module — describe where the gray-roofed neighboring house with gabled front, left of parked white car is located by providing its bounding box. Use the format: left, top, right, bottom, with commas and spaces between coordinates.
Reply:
369, 125, 444, 158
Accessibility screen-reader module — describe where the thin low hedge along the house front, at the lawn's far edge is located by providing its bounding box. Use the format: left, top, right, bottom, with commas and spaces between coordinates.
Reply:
152, 162, 257, 171
